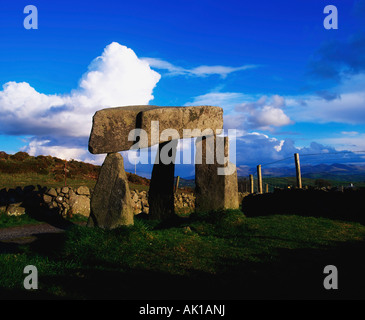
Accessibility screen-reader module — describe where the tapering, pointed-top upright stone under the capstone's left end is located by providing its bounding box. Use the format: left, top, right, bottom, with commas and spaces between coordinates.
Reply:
88, 153, 133, 229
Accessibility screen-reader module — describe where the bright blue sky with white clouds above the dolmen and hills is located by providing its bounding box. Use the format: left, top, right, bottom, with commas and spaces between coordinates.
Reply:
0, 0, 365, 176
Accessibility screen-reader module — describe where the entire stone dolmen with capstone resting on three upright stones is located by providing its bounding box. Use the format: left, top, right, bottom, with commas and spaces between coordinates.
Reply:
88, 105, 239, 229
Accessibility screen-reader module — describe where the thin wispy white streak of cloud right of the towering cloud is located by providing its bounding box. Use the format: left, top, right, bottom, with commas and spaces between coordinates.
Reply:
143, 58, 257, 78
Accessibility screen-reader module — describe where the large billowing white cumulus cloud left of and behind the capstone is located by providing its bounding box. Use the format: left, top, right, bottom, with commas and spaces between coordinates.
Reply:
0, 42, 161, 162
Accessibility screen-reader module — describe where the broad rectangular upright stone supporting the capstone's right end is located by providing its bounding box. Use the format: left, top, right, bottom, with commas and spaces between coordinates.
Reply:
195, 135, 239, 212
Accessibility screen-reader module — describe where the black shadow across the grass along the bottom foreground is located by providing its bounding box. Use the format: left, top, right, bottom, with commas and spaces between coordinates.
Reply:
0, 230, 365, 300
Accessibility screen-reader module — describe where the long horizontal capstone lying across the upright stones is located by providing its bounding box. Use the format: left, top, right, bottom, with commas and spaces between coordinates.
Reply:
89, 106, 223, 154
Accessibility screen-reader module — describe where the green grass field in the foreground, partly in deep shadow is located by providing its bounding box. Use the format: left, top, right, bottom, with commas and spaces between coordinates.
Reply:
0, 210, 365, 299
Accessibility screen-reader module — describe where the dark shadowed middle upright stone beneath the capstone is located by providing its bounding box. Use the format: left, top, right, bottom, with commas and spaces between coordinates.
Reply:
148, 140, 178, 220
